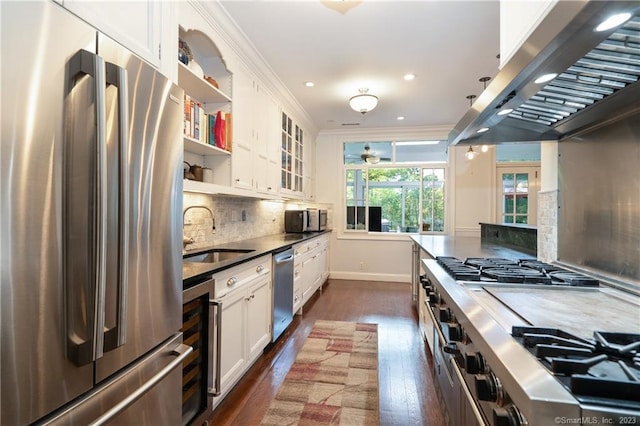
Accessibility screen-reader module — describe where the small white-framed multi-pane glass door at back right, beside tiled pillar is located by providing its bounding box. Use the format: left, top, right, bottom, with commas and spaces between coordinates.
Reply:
498, 167, 540, 225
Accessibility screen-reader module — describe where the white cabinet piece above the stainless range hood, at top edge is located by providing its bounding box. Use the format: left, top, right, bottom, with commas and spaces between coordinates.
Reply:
500, 0, 558, 68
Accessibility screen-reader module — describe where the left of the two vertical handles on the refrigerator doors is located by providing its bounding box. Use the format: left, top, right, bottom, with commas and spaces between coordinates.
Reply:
65, 49, 107, 366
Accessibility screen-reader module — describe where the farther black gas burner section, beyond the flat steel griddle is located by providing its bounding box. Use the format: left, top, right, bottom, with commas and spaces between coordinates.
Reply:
436, 257, 600, 287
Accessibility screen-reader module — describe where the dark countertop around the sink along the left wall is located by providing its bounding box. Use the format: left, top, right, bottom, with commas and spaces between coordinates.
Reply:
182, 230, 331, 284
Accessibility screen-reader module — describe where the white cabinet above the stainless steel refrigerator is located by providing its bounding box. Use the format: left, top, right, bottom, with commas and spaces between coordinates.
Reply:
62, 0, 162, 69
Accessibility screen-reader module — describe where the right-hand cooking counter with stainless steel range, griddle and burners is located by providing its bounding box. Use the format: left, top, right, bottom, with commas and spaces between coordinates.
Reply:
412, 236, 640, 425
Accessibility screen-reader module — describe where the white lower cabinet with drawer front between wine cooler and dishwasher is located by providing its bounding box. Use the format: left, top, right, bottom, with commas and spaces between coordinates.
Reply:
213, 255, 272, 407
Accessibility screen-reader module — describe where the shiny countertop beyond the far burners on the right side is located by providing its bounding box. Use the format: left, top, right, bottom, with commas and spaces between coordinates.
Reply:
411, 235, 535, 260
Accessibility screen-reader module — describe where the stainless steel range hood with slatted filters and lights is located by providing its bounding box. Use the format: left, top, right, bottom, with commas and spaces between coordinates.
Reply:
449, 0, 640, 144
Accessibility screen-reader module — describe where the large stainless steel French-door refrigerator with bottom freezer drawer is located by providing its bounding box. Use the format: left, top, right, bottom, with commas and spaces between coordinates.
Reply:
0, 1, 191, 425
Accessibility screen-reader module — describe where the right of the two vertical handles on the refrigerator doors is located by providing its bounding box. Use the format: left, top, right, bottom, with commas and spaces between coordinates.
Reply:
104, 62, 129, 352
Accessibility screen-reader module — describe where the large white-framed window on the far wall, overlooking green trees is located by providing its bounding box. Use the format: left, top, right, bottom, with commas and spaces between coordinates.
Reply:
344, 141, 446, 233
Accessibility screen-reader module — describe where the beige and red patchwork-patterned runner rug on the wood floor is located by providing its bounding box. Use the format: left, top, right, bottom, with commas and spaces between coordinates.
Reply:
261, 320, 379, 426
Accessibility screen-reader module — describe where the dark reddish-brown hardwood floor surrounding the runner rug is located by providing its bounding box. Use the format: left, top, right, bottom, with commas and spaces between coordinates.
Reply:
209, 280, 444, 426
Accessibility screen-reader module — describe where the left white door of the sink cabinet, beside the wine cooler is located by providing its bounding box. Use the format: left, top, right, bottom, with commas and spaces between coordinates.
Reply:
220, 290, 246, 392
